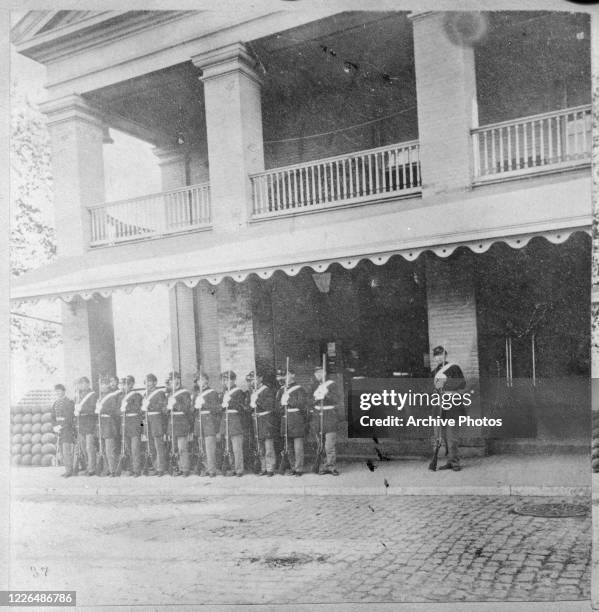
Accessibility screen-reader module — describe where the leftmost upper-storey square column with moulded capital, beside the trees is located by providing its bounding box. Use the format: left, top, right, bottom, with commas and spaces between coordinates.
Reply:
40, 94, 106, 257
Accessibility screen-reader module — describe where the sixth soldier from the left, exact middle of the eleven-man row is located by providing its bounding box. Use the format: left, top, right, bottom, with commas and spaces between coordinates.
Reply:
167, 372, 193, 477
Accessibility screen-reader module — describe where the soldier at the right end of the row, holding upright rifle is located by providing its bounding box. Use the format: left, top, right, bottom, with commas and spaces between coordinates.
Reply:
312, 365, 341, 476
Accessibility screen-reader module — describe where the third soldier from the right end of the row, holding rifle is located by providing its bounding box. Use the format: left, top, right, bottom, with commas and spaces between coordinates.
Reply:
246, 372, 277, 476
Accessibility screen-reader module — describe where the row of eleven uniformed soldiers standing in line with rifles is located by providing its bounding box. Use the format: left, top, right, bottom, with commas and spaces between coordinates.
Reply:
52, 366, 341, 477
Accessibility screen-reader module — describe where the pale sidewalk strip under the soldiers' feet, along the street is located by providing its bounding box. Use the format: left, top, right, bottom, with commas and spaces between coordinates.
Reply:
11, 454, 591, 496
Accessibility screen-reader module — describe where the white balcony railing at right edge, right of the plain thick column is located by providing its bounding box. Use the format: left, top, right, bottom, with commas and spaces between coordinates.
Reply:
472, 105, 591, 181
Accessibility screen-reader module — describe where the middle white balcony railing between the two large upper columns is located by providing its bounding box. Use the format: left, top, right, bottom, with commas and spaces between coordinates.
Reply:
251, 141, 421, 218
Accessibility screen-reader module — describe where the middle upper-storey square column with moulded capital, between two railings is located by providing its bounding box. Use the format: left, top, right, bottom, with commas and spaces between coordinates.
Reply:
192, 43, 264, 231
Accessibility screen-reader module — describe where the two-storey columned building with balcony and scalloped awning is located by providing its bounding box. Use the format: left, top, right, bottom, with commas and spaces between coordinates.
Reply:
12, 5, 591, 452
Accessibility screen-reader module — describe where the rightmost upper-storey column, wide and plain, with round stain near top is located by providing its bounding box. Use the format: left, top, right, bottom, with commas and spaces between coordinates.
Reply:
411, 12, 477, 198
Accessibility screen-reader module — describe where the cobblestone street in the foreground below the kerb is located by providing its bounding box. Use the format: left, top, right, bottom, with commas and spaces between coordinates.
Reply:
11, 495, 591, 605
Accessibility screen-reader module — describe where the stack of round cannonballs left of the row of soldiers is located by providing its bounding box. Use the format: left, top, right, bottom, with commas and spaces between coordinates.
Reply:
10, 391, 56, 466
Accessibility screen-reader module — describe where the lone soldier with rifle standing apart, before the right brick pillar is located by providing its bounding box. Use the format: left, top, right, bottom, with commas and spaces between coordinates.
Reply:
433, 346, 466, 472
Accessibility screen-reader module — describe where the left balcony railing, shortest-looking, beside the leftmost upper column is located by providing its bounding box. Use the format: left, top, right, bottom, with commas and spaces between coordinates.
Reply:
89, 183, 210, 246
